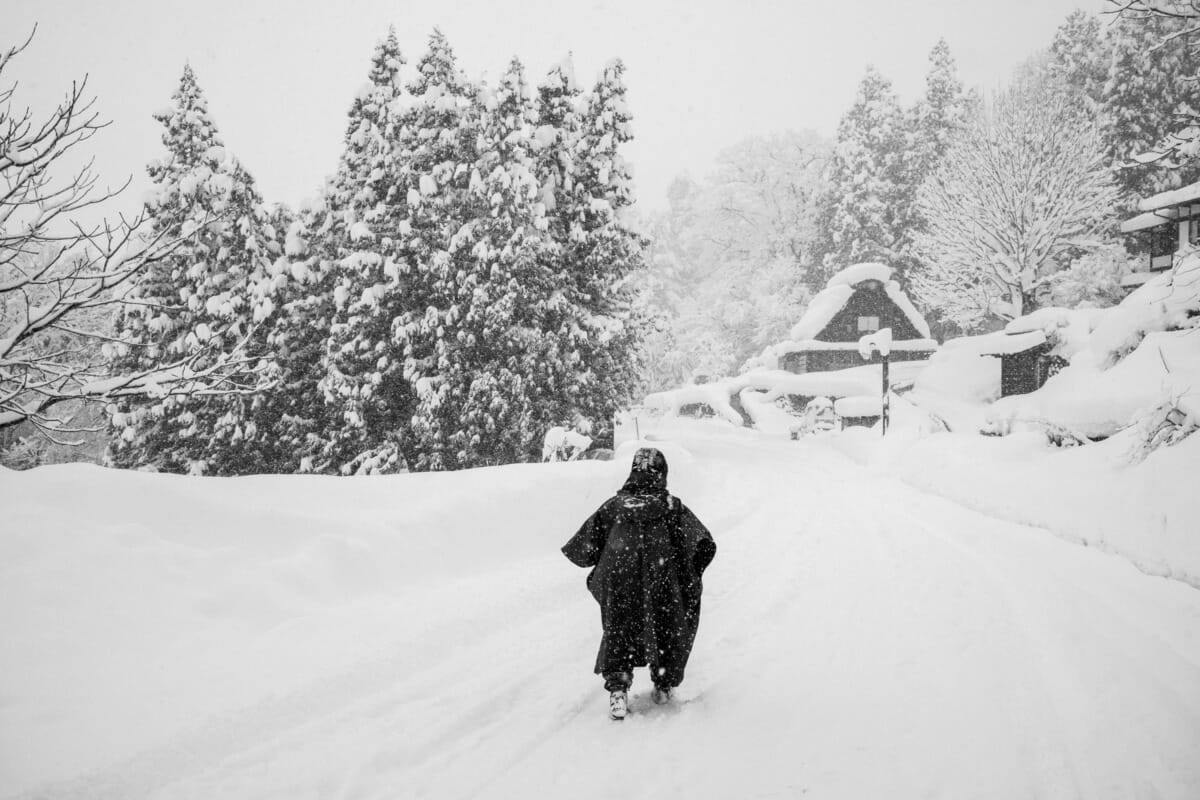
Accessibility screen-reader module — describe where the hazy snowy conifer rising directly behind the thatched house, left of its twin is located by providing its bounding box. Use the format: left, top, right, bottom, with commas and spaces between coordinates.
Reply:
808, 67, 906, 284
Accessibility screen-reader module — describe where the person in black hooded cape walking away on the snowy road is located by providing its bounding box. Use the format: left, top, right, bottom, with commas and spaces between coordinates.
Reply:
563, 447, 716, 720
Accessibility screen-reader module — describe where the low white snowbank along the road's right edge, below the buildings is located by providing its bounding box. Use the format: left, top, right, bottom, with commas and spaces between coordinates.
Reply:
823, 429, 1200, 588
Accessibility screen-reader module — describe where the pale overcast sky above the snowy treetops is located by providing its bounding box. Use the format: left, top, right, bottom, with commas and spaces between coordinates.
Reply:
7, 0, 1105, 210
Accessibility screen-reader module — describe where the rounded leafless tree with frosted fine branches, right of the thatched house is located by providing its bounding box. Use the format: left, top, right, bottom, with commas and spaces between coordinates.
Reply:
912, 84, 1116, 327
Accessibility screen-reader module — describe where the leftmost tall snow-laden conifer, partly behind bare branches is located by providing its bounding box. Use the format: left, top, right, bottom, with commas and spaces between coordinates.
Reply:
109, 66, 287, 475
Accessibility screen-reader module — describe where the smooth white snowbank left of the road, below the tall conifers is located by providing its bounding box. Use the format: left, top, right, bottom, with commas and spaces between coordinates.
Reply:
0, 460, 619, 796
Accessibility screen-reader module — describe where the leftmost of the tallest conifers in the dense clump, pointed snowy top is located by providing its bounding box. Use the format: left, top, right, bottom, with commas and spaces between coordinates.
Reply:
319, 29, 424, 473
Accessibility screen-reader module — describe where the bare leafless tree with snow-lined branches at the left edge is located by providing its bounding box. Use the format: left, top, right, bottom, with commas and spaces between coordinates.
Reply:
0, 36, 264, 432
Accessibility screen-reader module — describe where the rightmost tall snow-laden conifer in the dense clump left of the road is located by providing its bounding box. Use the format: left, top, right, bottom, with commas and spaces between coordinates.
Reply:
556, 60, 647, 450
